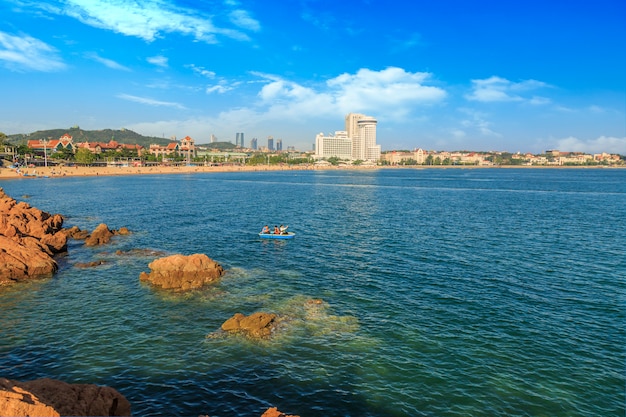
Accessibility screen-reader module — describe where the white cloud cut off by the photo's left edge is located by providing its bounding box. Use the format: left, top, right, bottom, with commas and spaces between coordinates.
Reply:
0, 32, 66, 72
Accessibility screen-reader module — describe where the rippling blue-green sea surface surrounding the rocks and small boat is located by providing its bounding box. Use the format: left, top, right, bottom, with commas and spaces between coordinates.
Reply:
0, 169, 626, 417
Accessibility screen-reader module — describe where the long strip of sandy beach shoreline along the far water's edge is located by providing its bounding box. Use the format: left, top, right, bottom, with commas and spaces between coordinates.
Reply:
0, 164, 626, 179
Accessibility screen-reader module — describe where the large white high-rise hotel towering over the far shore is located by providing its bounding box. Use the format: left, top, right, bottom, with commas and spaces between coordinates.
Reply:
315, 113, 380, 161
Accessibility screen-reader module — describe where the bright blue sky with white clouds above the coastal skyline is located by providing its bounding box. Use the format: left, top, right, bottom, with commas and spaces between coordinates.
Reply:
0, 0, 626, 154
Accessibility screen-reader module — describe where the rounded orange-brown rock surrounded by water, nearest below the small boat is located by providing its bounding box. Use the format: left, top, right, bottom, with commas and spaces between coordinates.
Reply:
139, 254, 224, 291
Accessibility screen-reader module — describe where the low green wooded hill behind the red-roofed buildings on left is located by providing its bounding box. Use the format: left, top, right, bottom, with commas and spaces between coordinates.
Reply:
7, 126, 173, 148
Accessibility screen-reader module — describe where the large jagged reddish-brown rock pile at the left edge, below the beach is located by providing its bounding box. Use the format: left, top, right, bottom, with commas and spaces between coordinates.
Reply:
0, 188, 67, 285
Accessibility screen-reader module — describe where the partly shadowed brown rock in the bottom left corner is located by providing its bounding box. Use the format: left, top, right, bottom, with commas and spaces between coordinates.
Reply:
0, 378, 131, 417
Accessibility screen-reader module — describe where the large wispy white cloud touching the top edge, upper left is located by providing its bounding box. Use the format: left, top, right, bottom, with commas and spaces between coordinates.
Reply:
51, 0, 260, 43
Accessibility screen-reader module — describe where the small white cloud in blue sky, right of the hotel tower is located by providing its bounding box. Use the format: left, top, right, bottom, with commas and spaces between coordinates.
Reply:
465, 76, 548, 104
